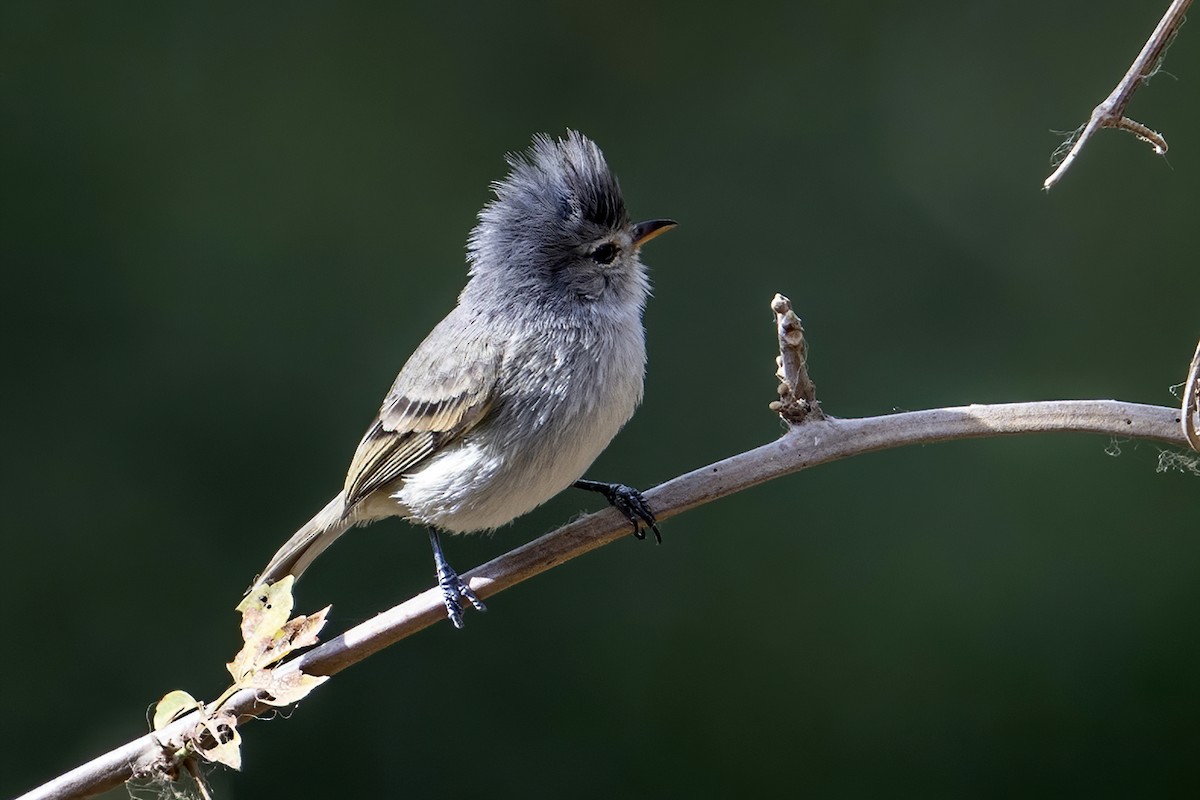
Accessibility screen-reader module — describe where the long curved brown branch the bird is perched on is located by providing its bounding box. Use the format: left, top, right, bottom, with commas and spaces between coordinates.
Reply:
19, 401, 1188, 800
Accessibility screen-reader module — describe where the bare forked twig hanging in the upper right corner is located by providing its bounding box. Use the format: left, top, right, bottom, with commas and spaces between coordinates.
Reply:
1042, 0, 1192, 190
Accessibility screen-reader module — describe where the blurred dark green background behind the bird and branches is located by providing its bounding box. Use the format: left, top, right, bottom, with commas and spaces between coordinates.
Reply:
0, 0, 1200, 799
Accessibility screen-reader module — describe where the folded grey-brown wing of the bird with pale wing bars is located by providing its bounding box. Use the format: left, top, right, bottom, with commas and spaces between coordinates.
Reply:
344, 313, 500, 509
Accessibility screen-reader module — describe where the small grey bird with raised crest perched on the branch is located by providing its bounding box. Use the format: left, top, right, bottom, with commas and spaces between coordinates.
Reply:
256, 131, 676, 627
